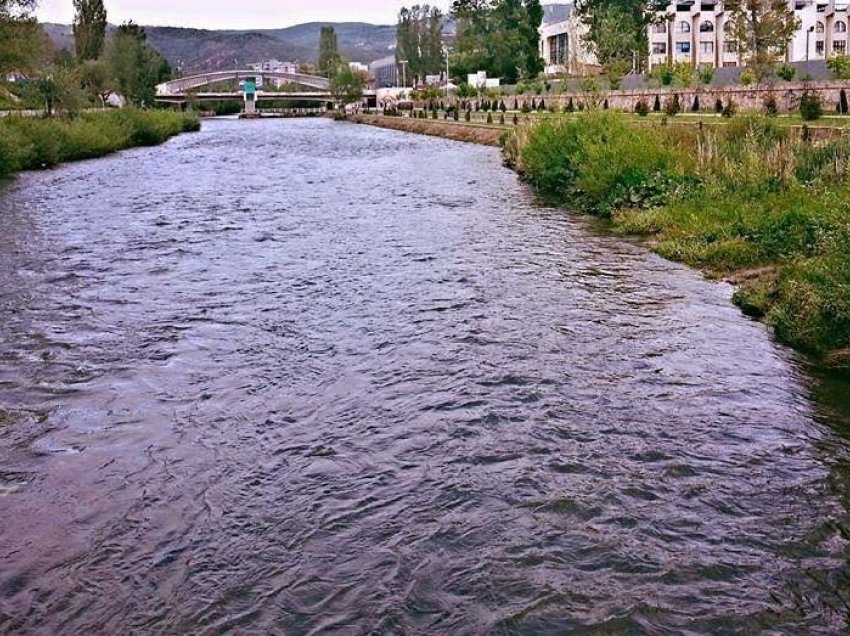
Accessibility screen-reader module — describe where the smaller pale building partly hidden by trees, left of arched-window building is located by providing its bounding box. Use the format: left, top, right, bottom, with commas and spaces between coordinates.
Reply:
540, 5, 600, 76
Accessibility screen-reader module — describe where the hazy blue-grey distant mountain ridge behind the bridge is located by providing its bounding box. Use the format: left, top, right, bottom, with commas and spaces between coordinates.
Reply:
43, 4, 572, 72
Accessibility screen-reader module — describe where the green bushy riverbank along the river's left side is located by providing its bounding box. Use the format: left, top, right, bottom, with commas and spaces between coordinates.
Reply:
0, 108, 200, 176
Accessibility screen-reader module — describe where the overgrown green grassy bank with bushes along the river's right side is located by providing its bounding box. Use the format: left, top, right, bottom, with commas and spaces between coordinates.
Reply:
505, 112, 850, 371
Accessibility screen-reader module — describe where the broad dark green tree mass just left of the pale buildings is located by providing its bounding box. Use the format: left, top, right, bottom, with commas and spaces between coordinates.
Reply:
452, 0, 543, 84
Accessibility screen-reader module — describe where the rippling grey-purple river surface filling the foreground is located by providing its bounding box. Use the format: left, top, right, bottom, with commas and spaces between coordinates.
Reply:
0, 120, 850, 634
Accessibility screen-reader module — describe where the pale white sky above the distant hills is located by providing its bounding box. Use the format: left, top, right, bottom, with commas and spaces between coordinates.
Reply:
36, 0, 449, 29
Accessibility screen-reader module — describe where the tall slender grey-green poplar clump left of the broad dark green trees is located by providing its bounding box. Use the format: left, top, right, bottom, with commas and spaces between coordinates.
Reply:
396, 4, 443, 78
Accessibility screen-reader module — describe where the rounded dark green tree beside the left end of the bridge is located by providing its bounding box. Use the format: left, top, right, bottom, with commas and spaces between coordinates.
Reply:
108, 22, 171, 106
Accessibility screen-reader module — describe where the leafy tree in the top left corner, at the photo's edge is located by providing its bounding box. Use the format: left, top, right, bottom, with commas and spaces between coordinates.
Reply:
0, 0, 46, 73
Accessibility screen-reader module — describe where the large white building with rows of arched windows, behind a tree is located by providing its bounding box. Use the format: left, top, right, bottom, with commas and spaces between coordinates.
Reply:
649, 0, 850, 68
